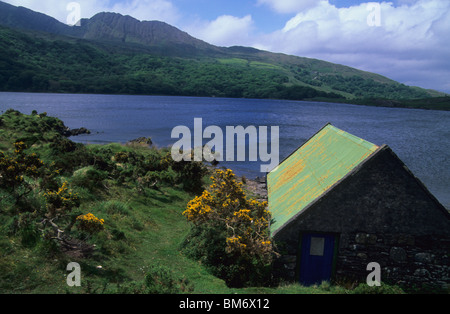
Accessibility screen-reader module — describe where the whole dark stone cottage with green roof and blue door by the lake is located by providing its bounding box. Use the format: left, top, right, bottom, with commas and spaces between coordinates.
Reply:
267, 124, 450, 288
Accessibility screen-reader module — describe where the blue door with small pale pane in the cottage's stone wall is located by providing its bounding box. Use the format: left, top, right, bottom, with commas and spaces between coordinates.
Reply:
299, 233, 335, 285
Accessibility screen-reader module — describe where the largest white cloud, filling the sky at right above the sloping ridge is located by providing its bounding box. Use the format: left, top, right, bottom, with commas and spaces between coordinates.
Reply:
254, 0, 450, 92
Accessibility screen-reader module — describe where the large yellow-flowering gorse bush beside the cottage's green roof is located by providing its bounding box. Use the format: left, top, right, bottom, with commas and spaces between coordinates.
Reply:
183, 169, 276, 287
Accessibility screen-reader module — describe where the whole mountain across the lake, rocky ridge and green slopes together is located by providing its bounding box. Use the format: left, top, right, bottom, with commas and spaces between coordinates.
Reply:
0, 2, 443, 106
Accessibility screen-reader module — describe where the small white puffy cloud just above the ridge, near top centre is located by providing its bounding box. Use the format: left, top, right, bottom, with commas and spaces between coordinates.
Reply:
184, 15, 253, 46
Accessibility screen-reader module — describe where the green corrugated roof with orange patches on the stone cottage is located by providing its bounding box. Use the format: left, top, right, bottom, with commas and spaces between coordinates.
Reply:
267, 124, 378, 234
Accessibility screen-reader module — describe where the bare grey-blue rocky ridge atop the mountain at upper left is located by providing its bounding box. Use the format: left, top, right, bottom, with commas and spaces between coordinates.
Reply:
0, 1, 220, 51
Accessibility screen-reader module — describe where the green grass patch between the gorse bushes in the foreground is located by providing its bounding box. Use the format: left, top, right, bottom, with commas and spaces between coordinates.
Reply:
0, 177, 406, 294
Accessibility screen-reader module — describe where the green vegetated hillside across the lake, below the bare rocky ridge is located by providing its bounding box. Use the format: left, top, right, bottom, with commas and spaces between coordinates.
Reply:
0, 27, 438, 100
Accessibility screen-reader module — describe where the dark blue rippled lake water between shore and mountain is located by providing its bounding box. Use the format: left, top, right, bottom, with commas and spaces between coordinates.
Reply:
0, 93, 450, 208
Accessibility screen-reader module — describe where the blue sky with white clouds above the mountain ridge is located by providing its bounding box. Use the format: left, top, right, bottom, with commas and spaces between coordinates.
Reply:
2, 0, 450, 93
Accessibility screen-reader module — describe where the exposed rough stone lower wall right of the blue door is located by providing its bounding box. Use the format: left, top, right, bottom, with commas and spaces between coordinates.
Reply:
335, 233, 450, 289
